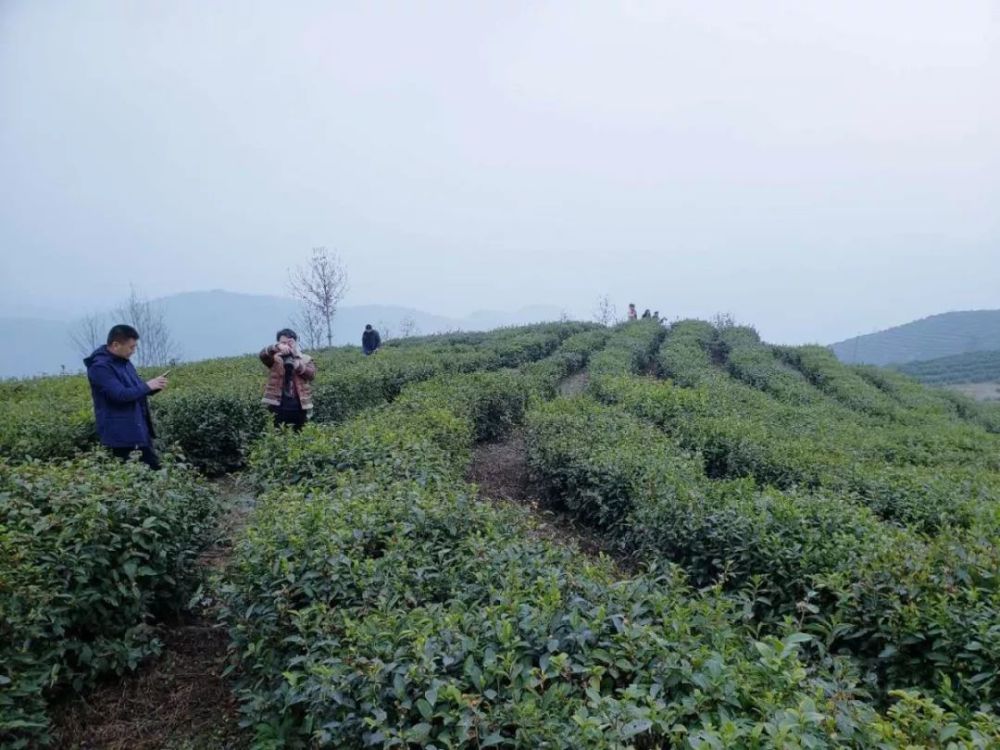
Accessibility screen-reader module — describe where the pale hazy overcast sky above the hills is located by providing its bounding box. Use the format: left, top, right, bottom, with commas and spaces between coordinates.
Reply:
0, 0, 1000, 342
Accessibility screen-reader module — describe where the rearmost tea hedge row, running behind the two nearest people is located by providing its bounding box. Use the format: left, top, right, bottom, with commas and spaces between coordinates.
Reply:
0, 323, 599, 474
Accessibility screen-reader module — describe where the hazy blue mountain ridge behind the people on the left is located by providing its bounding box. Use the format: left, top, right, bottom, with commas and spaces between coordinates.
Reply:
0, 289, 561, 378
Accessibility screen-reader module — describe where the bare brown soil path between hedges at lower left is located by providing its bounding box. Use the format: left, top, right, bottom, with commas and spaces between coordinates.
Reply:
54, 477, 253, 750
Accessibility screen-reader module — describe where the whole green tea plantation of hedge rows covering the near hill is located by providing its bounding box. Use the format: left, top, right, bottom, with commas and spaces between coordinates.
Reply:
0, 321, 1000, 749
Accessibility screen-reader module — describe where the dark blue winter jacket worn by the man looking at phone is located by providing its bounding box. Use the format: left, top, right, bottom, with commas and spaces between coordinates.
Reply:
83, 346, 154, 448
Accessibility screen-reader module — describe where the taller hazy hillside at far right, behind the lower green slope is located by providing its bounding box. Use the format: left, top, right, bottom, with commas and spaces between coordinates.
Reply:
831, 310, 1000, 365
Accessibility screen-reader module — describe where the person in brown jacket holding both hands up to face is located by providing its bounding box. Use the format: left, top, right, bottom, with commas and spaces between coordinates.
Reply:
260, 328, 316, 432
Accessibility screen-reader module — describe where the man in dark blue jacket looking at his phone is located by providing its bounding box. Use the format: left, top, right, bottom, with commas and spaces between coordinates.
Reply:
83, 325, 167, 469
